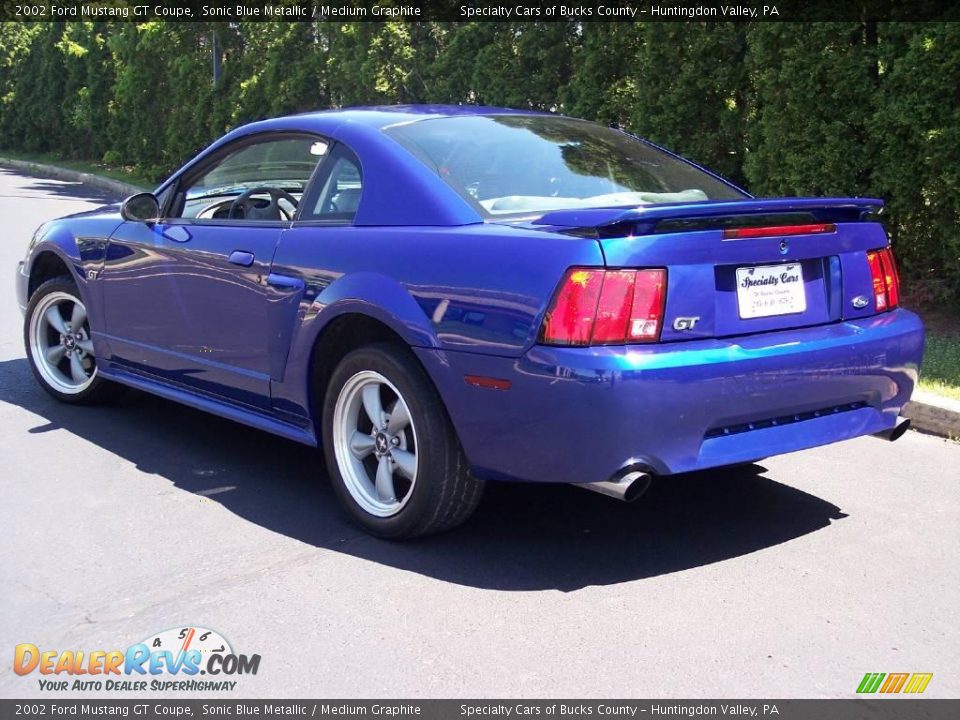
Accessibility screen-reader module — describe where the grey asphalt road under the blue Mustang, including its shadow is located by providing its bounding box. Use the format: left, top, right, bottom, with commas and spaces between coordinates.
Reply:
0, 170, 960, 698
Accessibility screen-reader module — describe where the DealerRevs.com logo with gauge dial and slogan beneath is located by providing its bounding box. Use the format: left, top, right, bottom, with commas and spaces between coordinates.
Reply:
13, 627, 260, 692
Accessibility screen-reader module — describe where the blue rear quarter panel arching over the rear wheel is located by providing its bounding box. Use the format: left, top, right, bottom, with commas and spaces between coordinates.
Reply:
273, 224, 603, 414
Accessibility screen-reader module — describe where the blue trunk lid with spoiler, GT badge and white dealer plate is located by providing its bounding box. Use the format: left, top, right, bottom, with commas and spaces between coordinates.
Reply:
533, 198, 887, 342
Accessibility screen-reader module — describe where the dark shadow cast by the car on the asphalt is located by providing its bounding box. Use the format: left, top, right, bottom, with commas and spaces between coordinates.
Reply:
0, 359, 846, 591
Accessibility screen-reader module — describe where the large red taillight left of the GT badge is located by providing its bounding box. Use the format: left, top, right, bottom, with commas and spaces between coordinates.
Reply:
540, 268, 667, 345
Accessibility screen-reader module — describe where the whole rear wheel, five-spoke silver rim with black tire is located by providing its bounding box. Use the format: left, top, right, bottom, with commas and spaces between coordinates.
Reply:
322, 344, 484, 539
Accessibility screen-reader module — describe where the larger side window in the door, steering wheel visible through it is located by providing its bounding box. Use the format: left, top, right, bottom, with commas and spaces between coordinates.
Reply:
170, 135, 330, 221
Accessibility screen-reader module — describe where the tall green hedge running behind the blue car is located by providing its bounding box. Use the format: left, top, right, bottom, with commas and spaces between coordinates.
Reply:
0, 22, 960, 307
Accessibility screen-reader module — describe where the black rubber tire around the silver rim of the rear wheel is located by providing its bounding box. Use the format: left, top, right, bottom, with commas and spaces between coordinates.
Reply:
321, 344, 484, 539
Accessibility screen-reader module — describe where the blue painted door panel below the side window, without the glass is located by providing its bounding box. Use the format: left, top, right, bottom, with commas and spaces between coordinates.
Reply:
98, 221, 297, 408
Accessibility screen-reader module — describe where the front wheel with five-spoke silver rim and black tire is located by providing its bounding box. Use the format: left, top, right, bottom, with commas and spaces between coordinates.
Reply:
23, 277, 116, 405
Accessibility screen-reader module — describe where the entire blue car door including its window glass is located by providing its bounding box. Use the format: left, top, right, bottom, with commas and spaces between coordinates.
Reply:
101, 134, 326, 409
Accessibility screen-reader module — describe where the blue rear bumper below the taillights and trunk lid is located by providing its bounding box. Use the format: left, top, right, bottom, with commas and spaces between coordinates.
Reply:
418, 309, 923, 482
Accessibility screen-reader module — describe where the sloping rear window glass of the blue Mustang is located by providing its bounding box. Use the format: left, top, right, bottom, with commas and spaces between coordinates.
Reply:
386, 115, 747, 217
